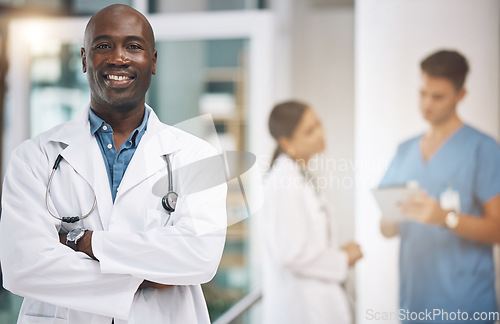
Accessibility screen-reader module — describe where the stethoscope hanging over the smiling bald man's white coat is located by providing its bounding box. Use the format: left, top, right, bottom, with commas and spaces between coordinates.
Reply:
45, 154, 178, 223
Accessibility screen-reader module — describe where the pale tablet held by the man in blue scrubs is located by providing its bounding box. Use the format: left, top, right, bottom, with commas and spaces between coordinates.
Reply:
372, 185, 422, 222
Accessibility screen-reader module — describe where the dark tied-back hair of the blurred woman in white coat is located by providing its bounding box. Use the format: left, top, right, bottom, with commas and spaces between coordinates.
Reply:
269, 100, 309, 168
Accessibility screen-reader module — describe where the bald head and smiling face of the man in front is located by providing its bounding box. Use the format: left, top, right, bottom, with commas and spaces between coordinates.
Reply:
81, 5, 157, 113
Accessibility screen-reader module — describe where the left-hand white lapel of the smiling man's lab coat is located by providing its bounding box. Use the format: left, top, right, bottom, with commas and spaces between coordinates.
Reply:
50, 108, 113, 229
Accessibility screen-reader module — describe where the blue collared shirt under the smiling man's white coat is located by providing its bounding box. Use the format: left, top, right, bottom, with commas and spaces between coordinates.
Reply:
89, 108, 149, 202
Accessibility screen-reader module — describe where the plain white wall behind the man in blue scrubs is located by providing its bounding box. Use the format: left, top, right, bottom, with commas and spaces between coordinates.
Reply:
355, 0, 500, 323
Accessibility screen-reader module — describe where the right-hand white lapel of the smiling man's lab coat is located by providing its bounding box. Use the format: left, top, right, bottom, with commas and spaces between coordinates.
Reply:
116, 106, 180, 200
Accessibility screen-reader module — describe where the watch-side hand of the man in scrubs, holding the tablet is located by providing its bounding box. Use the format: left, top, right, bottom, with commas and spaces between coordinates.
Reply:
401, 193, 447, 225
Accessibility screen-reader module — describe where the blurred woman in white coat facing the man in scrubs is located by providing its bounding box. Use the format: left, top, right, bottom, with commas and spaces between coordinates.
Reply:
262, 101, 362, 324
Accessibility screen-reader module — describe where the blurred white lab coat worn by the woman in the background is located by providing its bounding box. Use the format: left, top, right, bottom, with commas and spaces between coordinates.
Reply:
261, 154, 352, 324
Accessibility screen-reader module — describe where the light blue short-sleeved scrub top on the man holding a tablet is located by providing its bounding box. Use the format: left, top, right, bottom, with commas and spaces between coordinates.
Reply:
380, 125, 500, 323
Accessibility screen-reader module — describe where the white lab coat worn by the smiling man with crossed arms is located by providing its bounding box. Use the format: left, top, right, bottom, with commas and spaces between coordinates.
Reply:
0, 107, 226, 324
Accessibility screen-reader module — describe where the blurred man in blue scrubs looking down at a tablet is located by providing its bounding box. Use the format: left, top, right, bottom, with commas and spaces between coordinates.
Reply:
380, 51, 500, 323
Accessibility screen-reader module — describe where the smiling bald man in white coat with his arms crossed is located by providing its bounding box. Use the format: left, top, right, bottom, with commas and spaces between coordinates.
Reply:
0, 5, 226, 324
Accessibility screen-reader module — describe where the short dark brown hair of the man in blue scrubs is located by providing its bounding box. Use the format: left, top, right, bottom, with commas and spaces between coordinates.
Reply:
420, 50, 469, 90
